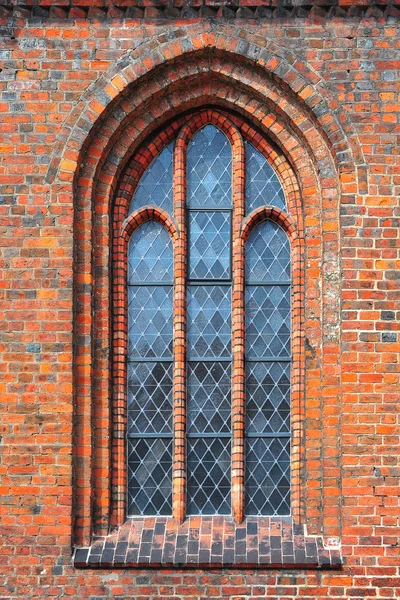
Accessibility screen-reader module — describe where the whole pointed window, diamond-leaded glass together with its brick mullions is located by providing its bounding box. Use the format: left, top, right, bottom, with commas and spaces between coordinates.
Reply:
114, 111, 293, 521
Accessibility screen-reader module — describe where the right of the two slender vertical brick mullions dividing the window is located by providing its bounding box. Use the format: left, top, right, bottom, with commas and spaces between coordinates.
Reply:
231, 132, 246, 523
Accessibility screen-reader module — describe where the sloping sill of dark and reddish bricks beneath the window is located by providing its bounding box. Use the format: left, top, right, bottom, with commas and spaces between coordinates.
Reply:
74, 517, 342, 569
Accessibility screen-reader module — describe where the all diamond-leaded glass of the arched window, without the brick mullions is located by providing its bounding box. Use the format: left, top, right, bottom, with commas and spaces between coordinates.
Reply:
126, 116, 291, 516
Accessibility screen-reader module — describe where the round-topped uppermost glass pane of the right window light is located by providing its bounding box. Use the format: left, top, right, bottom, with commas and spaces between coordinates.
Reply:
246, 221, 290, 283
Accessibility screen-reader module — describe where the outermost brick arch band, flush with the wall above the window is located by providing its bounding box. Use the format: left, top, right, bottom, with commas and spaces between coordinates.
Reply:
47, 23, 365, 188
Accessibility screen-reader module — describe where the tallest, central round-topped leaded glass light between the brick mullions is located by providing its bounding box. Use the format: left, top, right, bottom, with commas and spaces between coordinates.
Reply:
187, 125, 232, 515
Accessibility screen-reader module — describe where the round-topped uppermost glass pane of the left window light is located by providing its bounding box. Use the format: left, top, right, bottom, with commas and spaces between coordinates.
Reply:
128, 221, 173, 284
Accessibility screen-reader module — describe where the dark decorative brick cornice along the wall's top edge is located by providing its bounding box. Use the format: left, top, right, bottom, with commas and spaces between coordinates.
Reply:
1, 0, 400, 21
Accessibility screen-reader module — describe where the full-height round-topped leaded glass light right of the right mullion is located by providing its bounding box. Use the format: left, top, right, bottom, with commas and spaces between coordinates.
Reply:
245, 221, 291, 515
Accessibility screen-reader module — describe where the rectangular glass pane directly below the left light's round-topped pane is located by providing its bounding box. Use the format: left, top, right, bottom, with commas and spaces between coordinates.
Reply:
128, 285, 172, 358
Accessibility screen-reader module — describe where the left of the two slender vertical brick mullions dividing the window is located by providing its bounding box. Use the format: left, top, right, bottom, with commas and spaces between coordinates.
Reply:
172, 135, 187, 523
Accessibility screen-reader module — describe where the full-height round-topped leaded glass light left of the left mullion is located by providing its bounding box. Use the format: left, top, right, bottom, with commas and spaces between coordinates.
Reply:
127, 221, 173, 515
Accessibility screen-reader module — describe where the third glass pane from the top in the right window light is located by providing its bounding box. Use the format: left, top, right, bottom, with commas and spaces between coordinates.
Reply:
246, 362, 290, 434
